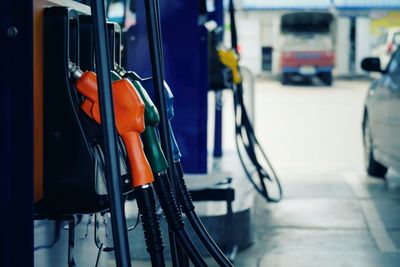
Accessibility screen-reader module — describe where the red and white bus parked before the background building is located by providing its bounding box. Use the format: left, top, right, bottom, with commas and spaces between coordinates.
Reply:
280, 12, 335, 85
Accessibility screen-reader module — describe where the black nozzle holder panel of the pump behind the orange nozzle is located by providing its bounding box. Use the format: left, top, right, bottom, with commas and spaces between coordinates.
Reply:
35, 7, 133, 266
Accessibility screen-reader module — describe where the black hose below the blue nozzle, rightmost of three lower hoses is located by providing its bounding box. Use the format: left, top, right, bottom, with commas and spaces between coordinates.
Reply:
174, 161, 233, 267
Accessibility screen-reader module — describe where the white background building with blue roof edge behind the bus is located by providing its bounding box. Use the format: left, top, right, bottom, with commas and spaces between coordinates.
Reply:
238, 0, 400, 76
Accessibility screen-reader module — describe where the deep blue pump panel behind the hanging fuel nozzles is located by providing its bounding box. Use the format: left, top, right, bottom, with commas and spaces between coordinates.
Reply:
125, 0, 208, 173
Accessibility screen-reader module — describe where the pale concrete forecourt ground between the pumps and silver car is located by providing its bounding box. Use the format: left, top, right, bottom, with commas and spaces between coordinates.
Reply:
227, 81, 400, 267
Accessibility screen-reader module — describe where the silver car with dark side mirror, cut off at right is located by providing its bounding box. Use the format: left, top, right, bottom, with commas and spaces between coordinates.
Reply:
361, 49, 400, 178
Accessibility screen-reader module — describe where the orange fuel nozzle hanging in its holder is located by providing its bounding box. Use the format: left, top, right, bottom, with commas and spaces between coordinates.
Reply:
69, 64, 154, 187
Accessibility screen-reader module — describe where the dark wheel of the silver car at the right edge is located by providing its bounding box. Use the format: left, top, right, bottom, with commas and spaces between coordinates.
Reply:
363, 113, 387, 178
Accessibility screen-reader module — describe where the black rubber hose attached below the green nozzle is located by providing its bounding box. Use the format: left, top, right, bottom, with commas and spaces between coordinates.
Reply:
153, 172, 207, 267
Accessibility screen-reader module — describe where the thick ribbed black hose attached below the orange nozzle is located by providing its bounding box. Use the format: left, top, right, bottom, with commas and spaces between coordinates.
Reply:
135, 185, 165, 267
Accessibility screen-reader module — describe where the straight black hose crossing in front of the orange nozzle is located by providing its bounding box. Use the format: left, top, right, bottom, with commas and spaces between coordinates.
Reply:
91, 0, 131, 267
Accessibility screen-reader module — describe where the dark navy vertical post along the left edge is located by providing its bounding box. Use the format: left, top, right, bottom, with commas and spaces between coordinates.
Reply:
0, 0, 33, 267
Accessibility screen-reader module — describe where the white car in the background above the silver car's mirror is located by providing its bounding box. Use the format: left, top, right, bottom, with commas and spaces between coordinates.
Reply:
372, 27, 400, 69
